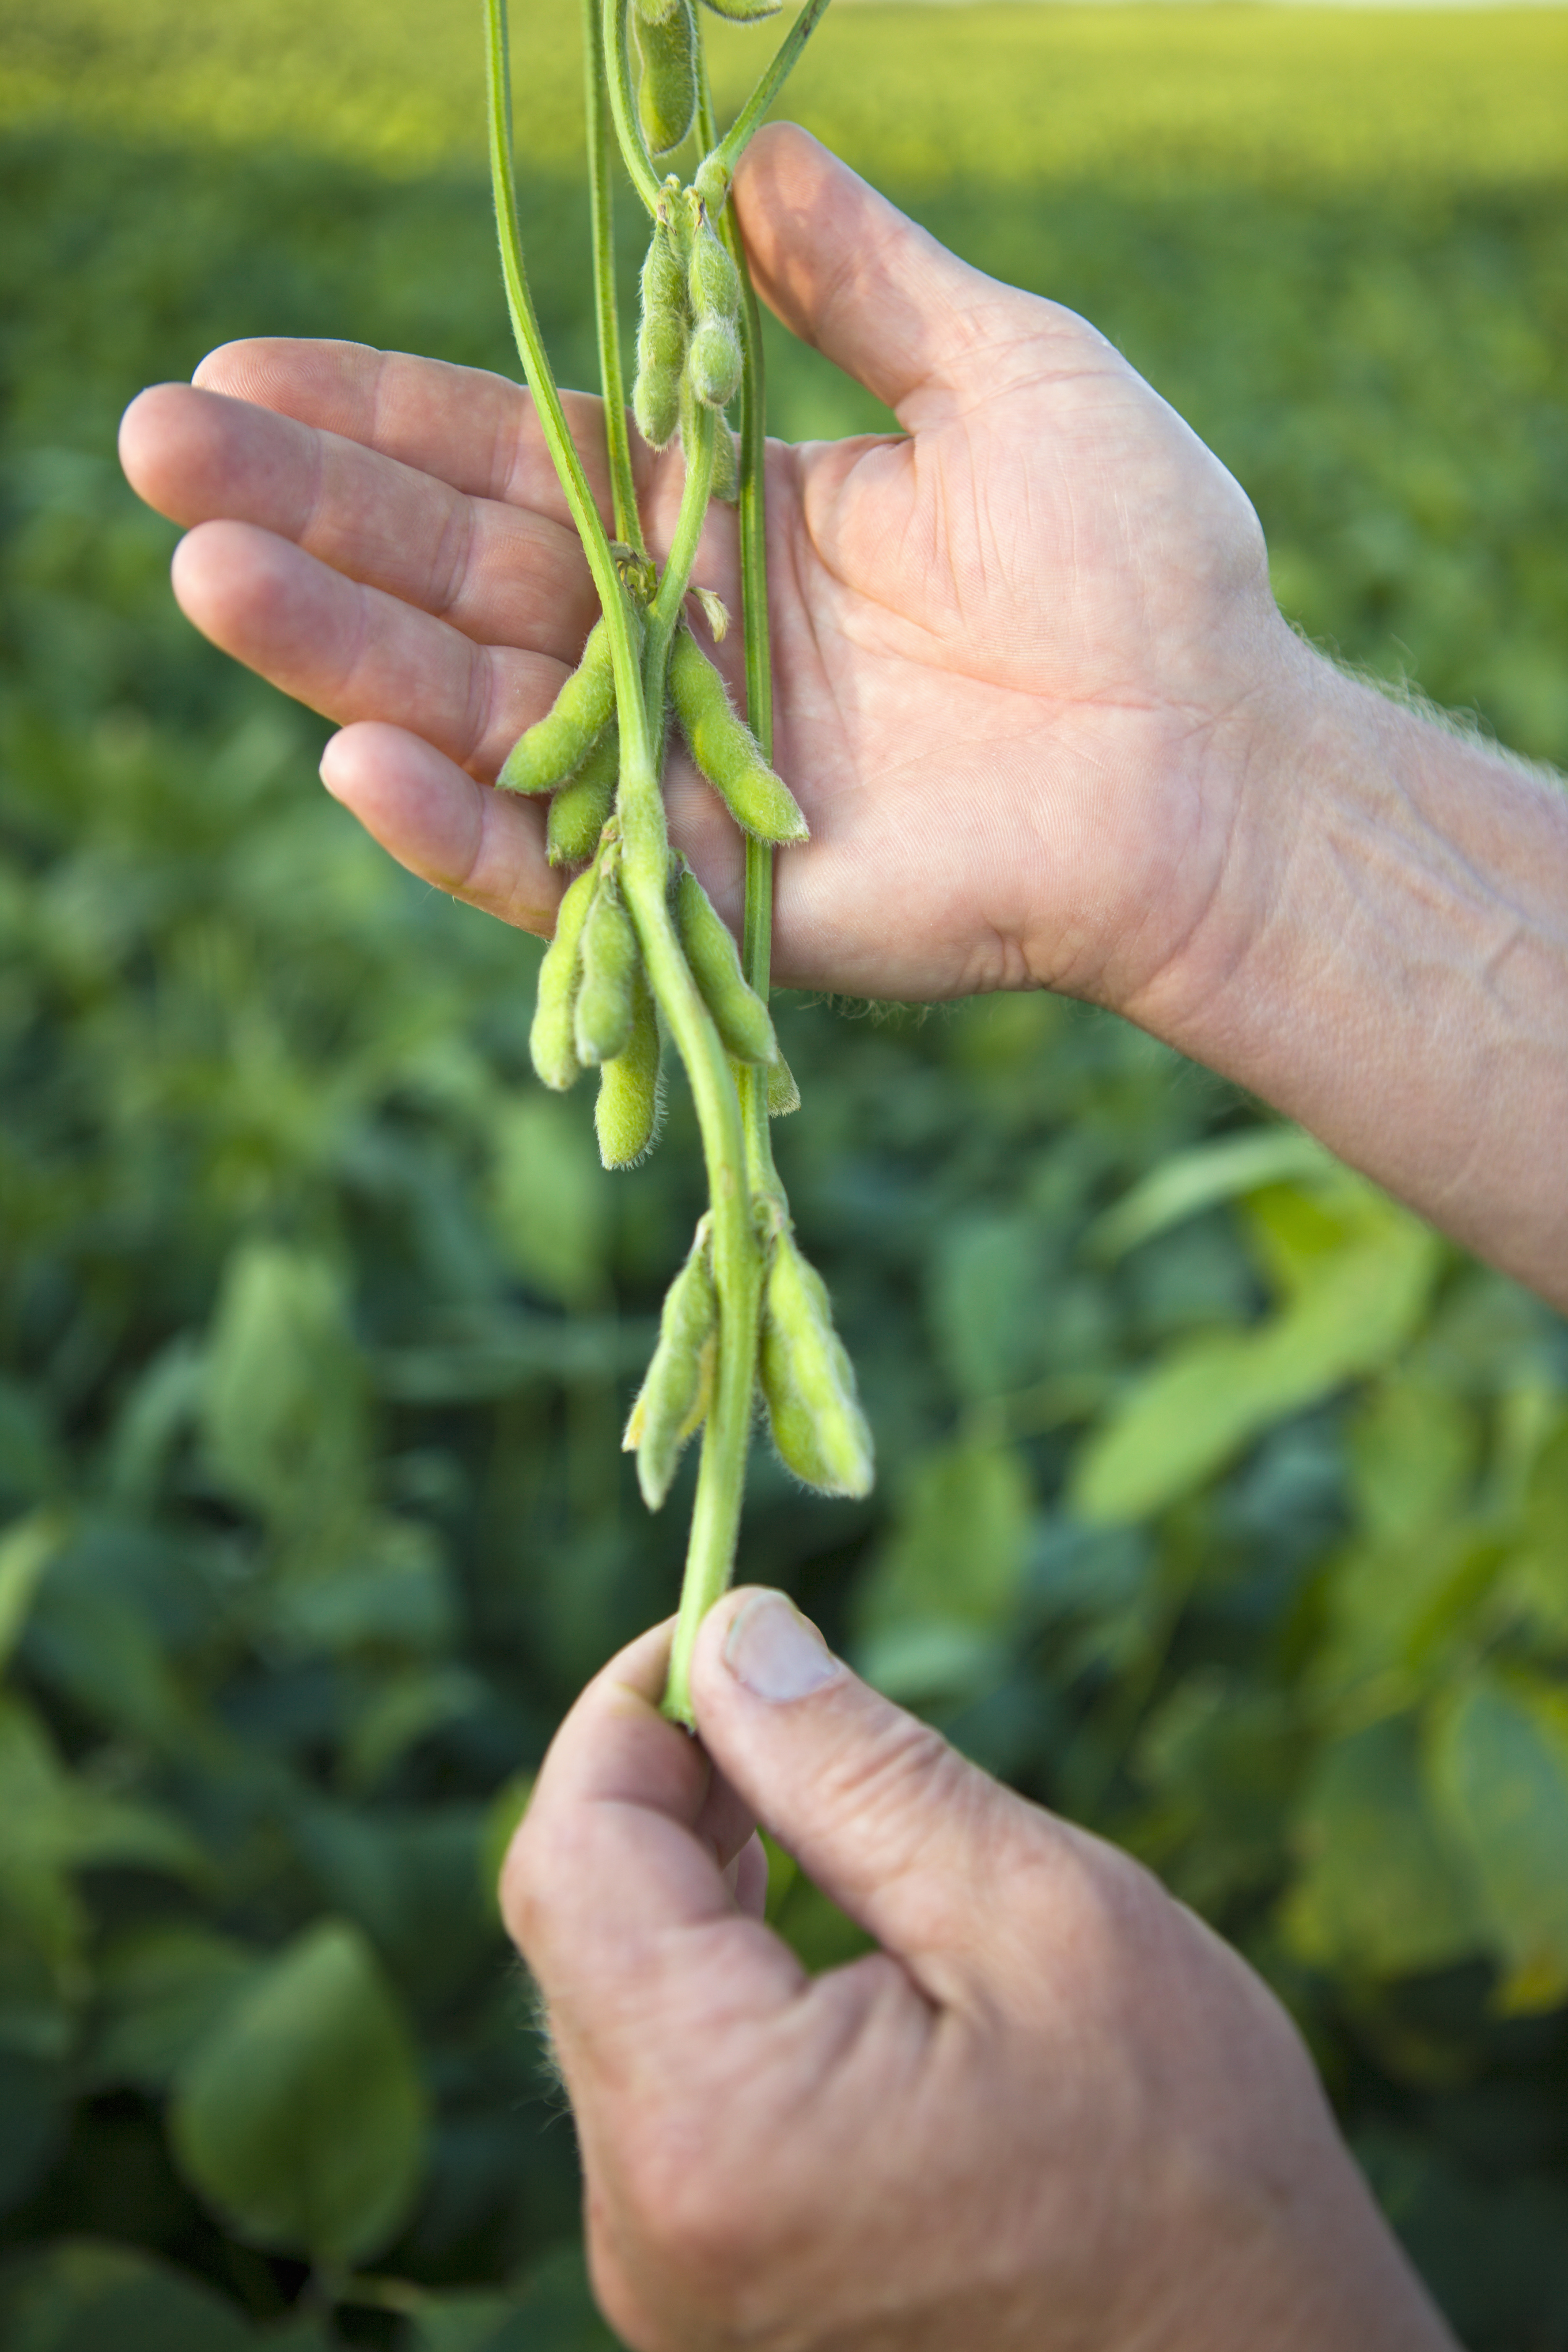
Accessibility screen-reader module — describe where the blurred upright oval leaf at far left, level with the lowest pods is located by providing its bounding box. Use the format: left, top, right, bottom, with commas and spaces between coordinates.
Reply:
202, 1242, 365, 1519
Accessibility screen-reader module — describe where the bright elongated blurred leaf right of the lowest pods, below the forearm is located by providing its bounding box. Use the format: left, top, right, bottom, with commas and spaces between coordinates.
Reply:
1070, 1188, 1441, 1524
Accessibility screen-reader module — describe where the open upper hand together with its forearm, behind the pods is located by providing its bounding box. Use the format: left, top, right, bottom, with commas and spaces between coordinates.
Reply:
122, 127, 1568, 1305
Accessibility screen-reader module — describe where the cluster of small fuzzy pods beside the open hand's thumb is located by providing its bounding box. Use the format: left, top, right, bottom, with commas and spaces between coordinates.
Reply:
632, 179, 740, 451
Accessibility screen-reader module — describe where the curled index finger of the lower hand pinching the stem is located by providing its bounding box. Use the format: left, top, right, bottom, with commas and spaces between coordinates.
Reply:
501, 1625, 804, 2070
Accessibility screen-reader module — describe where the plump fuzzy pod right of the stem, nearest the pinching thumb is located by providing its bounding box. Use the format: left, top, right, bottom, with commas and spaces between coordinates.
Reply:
757, 1225, 875, 1496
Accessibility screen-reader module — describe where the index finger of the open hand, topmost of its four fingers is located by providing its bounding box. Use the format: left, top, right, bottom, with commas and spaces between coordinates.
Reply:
193, 336, 609, 525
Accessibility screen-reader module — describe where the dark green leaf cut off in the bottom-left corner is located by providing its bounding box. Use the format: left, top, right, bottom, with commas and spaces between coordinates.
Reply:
0, 2239, 259, 2352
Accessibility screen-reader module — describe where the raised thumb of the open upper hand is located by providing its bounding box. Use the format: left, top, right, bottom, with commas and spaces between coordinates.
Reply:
733, 122, 1048, 430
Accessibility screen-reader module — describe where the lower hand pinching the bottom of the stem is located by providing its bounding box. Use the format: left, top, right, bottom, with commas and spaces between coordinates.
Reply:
503, 1592, 1453, 2352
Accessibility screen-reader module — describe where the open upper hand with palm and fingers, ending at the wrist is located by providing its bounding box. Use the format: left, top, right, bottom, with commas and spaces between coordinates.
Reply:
122, 127, 1281, 1009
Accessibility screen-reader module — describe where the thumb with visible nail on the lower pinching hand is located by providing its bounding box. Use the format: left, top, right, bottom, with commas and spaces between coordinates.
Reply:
691, 1588, 1062, 1973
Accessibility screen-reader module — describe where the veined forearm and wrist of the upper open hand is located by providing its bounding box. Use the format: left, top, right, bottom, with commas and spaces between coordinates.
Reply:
1128, 640, 1568, 1308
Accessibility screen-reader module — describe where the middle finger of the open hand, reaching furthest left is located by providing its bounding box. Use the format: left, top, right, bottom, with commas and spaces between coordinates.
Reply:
120, 383, 597, 661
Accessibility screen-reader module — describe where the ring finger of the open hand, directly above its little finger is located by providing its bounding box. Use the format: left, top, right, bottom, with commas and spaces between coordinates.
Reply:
174, 522, 567, 776
